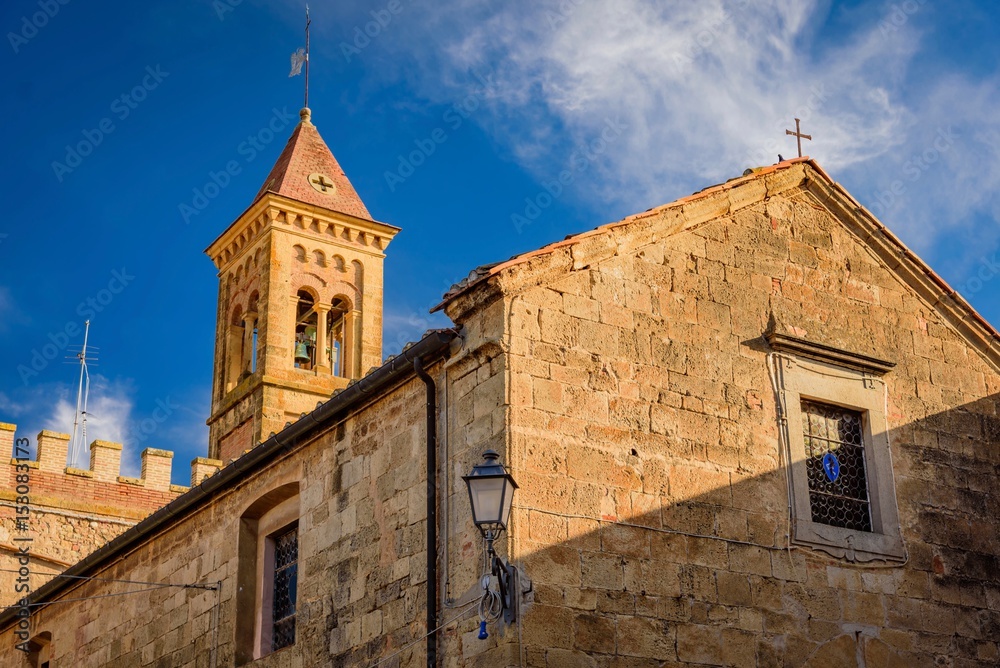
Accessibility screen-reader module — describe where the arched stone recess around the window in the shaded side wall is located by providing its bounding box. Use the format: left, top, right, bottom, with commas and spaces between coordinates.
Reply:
235, 481, 304, 666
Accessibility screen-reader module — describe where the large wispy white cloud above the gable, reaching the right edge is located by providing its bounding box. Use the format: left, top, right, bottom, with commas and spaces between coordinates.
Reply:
332, 0, 1000, 268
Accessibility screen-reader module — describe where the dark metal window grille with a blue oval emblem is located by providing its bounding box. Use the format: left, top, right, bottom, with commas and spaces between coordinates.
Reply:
802, 400, 872, 531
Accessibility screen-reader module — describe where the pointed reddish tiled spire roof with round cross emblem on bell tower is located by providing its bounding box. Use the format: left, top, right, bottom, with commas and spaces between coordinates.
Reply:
254, 108, 372, 220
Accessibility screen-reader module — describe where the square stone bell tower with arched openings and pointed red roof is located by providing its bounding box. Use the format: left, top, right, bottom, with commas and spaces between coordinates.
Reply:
205, 108, 399, 461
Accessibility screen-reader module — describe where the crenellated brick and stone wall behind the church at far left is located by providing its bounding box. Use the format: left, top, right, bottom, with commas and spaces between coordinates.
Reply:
0, 422, 221, 604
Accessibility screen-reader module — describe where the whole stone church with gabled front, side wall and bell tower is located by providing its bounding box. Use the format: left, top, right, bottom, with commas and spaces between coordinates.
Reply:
0, 107, 1000, 668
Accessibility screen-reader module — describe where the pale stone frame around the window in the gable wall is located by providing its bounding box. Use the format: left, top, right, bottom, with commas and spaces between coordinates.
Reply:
766, 333, 906, 562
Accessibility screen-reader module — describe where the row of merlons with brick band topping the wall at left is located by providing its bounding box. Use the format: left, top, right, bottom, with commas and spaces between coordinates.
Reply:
0, 422, 222, 495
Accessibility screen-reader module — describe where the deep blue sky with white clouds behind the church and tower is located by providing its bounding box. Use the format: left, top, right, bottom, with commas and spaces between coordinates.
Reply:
0, 0, 1000, 484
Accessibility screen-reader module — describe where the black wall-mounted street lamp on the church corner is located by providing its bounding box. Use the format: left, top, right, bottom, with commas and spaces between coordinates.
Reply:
462, 450, 517, 639
